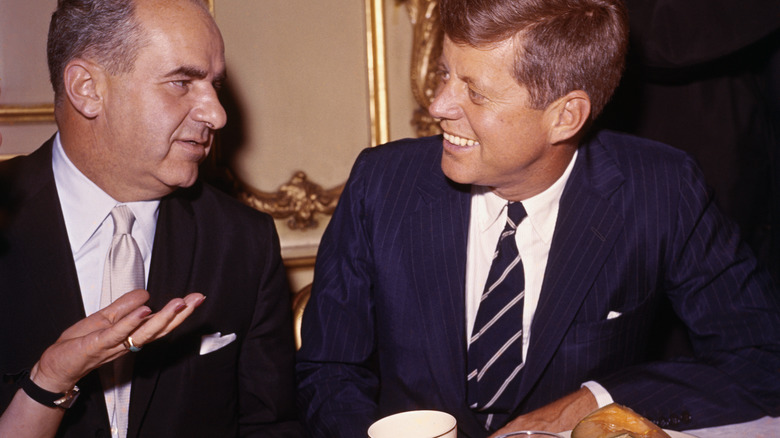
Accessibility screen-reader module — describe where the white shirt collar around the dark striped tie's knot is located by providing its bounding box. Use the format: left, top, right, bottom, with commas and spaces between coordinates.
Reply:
472, 150, 578, 243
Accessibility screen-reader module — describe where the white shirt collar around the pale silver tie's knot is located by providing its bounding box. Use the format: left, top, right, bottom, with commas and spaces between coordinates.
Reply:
52, 133, 160, 254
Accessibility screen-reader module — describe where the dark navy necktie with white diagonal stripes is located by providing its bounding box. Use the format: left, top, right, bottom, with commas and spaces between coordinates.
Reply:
467, 202, 526, 429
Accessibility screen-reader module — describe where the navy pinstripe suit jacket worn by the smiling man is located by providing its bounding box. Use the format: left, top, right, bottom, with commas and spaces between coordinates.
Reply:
297, 132, 780, 438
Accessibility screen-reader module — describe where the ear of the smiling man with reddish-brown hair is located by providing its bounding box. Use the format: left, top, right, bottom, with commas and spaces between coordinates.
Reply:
547, 90, 590, 144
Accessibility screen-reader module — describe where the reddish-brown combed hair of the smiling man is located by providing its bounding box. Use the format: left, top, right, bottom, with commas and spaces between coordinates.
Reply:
439, 0, 628, 119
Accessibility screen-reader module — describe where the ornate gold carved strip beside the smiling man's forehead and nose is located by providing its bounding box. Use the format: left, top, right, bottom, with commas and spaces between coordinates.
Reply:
399, 0, 443, 136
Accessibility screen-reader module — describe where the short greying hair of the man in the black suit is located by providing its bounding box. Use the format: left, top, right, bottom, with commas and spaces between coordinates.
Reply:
46, 0, 146, 103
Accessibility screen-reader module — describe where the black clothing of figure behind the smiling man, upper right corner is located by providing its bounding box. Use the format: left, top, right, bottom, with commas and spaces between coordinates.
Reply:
597, 0, 780, 281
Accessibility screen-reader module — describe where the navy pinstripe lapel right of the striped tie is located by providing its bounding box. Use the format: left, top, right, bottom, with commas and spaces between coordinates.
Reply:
518, 142, 623, 404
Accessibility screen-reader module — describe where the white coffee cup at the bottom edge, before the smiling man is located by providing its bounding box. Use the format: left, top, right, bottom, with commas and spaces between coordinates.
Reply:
368, 411, 458, 438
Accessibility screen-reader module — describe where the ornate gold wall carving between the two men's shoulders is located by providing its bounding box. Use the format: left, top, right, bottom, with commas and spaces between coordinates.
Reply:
238, 171, 344, 230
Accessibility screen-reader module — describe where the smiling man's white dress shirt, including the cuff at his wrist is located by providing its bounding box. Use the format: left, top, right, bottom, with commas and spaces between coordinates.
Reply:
466, 151, 612, 407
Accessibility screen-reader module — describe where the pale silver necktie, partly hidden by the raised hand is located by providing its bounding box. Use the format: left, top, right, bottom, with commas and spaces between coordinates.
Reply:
100, 205, 144, 438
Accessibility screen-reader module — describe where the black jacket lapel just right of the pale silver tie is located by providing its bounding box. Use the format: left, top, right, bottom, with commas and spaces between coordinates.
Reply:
128, 189, 197, 437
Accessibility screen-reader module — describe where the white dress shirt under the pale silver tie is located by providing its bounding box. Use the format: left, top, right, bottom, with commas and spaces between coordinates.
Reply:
52, 133, 160, 438
